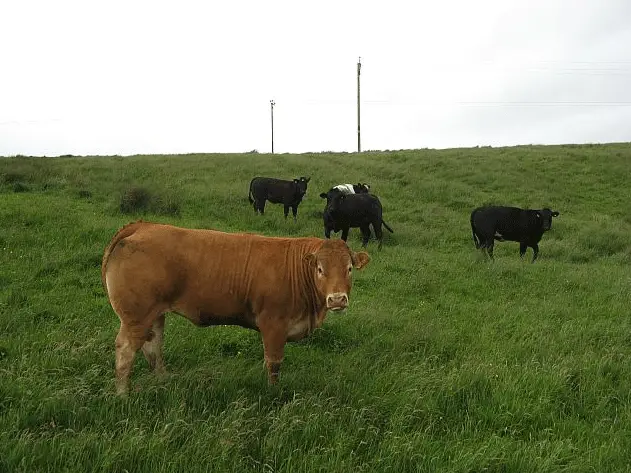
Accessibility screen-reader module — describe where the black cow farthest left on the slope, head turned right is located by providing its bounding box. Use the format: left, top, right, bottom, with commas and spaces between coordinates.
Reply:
248, 176, 311, 220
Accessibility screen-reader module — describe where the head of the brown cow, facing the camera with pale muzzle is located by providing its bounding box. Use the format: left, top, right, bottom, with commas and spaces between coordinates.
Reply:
304, 240, 370, 310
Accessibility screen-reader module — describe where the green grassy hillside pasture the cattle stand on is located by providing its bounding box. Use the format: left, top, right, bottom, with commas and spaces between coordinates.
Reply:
0, 144, 631, 473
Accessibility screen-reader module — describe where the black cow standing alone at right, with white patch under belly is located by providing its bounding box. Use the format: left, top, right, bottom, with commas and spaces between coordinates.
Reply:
471, 206, 559, 263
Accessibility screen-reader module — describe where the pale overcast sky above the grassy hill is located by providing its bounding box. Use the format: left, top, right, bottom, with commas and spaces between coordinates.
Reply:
0, 0, 631, 156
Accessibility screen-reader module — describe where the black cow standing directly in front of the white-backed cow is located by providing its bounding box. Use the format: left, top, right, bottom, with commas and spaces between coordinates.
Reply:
320, 189, 394, 249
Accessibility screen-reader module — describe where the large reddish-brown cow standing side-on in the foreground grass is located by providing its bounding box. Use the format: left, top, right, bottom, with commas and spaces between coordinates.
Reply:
101, 221, 370, 394
